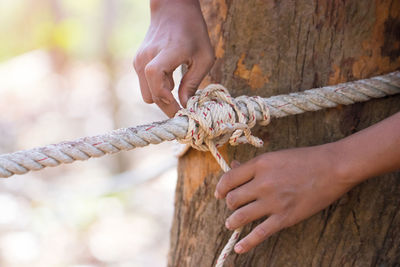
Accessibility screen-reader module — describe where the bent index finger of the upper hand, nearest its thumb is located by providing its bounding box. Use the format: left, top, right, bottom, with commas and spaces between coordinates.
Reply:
145, 51, 181, 118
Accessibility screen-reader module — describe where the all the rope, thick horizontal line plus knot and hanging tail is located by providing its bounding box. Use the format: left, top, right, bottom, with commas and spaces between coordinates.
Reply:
0, 71, 400, 266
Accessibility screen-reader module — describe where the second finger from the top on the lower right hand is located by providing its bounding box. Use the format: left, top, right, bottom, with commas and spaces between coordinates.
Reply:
226, 181, 258, 210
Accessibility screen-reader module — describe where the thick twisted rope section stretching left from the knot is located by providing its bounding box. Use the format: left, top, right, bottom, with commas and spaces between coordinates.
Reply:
0, 117, 187, 177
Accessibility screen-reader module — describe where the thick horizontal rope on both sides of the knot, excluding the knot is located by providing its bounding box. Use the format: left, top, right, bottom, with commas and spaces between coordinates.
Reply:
0, 71, 400, 177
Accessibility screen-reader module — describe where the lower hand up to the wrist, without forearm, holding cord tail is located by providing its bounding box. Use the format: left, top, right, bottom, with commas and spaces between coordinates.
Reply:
215, 143, 355, 253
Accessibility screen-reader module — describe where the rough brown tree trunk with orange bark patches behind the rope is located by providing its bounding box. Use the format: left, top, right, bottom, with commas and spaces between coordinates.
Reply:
169, 0, 400, 266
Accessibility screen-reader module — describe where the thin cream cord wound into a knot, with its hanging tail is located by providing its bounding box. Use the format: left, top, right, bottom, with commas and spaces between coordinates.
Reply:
175, 84, 271, 267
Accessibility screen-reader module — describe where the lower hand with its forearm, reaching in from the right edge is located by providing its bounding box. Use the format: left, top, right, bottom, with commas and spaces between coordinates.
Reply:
215, 112, 400, 253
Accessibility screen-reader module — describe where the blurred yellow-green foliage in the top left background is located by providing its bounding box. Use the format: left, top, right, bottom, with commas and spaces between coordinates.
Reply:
0, 0, 150, 60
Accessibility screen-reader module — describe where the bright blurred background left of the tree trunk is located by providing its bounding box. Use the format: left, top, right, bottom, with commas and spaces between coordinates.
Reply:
0, 0, 179, 267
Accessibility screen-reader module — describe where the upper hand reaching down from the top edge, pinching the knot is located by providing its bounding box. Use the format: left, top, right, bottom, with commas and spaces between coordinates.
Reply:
134, 0, 214, 117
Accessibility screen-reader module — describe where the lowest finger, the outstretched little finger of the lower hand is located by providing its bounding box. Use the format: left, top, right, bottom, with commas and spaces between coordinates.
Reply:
235, 215, 283, 254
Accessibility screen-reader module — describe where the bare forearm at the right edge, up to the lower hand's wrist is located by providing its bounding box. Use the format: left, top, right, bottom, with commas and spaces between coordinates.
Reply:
331, 112, 400, 184
